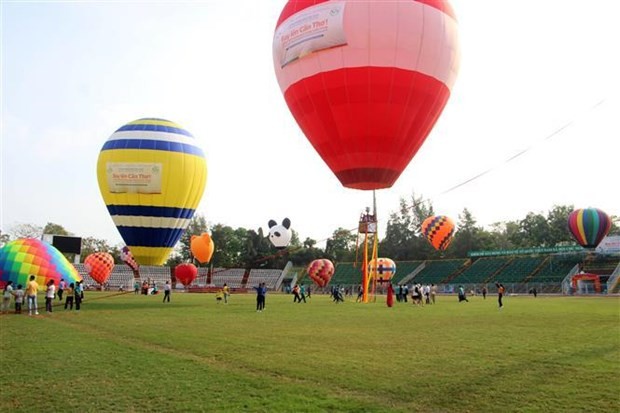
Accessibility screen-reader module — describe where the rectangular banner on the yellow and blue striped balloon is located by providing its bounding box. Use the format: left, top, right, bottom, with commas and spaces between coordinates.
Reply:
106, 162, 162, 194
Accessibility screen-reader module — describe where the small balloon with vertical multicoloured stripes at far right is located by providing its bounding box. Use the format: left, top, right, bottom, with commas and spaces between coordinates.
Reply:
568, 208, 611, 248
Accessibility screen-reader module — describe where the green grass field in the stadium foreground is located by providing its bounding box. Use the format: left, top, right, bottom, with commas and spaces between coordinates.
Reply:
0, 292, 620, 412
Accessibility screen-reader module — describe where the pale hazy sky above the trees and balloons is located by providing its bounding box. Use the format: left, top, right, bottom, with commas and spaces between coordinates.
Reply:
0, 0, 620, 245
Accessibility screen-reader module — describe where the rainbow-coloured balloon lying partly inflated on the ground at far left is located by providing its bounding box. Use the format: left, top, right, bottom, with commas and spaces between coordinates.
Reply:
0, 238, 82, 290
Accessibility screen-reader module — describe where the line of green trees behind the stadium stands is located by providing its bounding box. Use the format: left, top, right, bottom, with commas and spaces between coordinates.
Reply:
0, 194, 620, 268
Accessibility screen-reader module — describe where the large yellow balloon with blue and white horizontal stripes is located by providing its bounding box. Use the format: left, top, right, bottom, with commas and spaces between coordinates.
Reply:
97, 118, 207, 265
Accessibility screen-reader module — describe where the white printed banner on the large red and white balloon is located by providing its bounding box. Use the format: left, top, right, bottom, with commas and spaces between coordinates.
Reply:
273, 2, 347, 67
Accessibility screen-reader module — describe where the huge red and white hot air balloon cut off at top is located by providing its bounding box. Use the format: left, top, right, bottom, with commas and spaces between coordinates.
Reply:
273, 0, 459, 190
